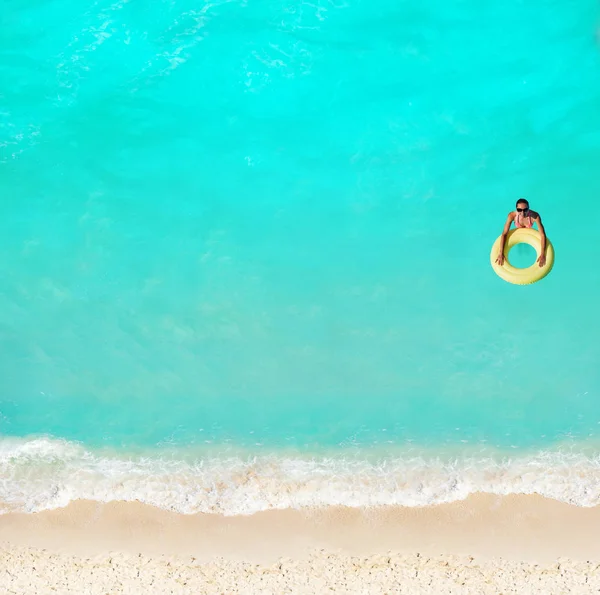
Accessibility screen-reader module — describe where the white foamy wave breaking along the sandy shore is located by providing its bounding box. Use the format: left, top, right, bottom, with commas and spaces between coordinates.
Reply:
0, 438, 600, 515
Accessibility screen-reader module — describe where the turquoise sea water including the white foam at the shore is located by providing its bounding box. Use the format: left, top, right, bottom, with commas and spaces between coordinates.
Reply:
0, 0, 600, 514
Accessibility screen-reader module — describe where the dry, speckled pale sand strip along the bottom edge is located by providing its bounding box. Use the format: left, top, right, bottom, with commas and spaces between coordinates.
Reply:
0, 546, 600, 595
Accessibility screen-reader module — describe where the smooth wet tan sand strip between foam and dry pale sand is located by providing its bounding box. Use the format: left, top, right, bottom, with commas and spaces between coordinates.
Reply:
0, 494, 600, 563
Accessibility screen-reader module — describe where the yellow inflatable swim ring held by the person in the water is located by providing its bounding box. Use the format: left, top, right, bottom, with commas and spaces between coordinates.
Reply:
490, 227, 554, 285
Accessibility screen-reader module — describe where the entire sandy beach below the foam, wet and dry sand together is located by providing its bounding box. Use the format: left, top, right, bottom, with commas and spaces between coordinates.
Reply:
0, 495, 600, 595
